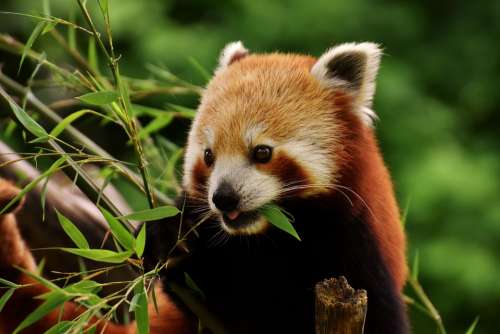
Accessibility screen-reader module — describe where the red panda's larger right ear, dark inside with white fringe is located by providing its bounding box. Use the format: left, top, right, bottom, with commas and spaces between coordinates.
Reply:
311, 43, 382, 124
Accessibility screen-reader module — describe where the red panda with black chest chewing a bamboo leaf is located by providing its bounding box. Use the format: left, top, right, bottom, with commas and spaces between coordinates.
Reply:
0, 42, 409, 334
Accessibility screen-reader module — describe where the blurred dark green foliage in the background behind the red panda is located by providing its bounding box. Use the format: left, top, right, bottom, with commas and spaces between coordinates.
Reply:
0, 0, 500, 333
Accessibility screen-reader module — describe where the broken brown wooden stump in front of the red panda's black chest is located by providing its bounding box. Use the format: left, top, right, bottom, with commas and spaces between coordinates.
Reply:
315, 276, 368, 334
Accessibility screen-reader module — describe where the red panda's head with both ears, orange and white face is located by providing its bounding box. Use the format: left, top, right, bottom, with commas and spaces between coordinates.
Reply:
184, 42, 381, 234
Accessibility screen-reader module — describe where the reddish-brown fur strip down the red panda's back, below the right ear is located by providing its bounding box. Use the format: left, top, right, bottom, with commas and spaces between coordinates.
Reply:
332, 93, 407, 290
